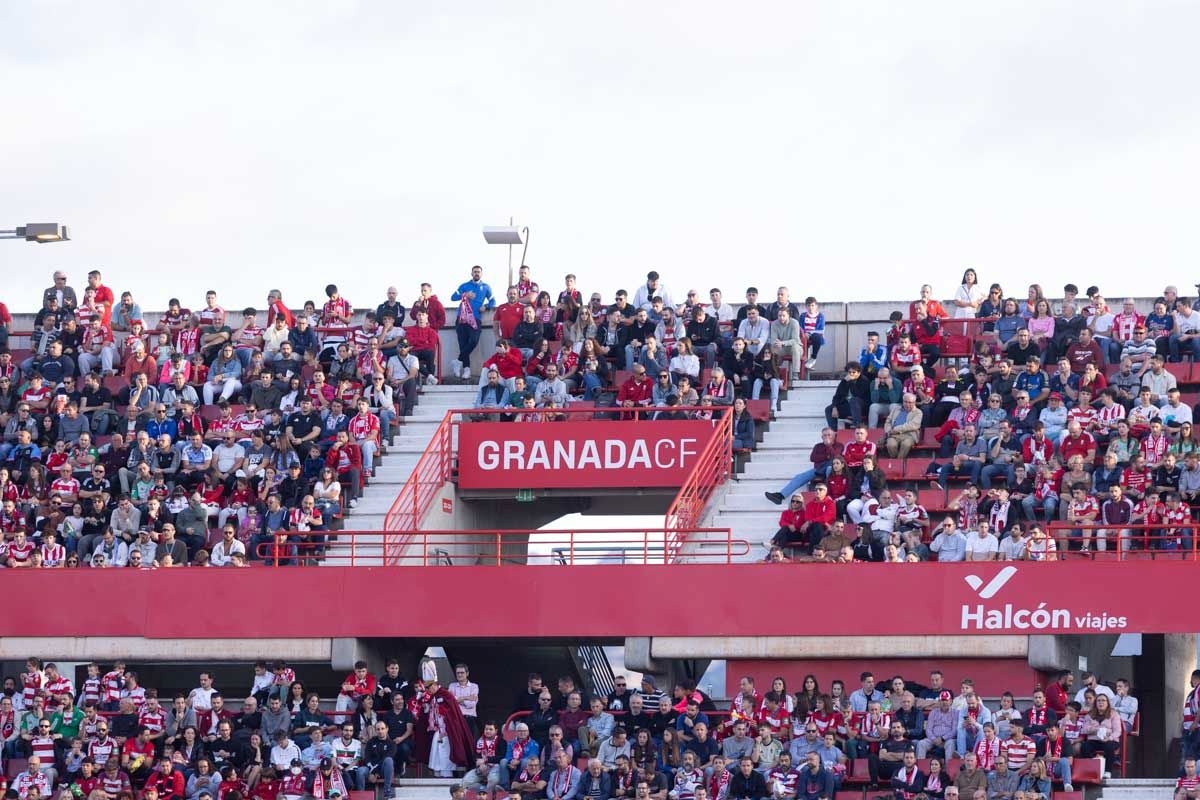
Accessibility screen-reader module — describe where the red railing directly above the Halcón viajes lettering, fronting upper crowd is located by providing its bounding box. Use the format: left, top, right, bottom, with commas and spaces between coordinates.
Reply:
1048, 519, 1200, 561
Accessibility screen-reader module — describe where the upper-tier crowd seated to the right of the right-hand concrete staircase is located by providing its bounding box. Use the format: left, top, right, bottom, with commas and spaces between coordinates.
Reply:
767, 278, 1200, 563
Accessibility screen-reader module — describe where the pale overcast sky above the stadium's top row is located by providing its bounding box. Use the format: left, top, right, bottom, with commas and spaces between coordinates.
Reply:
0, 0, 1200, 311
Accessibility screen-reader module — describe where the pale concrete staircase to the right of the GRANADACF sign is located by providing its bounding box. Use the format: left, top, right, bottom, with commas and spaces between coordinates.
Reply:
708, 380, 838, 560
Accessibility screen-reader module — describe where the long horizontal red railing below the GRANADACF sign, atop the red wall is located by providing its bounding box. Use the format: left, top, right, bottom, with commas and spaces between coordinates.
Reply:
252, 528, 750, 566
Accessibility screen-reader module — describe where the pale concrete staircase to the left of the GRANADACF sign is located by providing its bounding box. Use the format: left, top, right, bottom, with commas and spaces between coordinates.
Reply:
322, 384, 475, 563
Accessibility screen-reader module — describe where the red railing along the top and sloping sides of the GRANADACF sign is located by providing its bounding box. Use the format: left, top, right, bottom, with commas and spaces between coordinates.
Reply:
384, 405, 733, 565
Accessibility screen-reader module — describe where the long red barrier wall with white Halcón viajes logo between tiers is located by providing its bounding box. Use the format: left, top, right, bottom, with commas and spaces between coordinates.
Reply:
0, 561, 1200, 638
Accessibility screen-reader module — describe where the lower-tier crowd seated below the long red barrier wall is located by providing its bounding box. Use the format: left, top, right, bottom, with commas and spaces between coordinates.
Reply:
0, 658, 1161, 800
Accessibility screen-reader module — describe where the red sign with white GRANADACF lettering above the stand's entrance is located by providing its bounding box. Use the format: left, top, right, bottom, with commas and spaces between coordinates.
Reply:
458, 420, 714, 489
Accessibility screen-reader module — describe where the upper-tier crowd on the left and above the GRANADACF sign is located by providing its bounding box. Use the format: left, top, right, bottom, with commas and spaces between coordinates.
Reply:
0, 266, 824, 569
